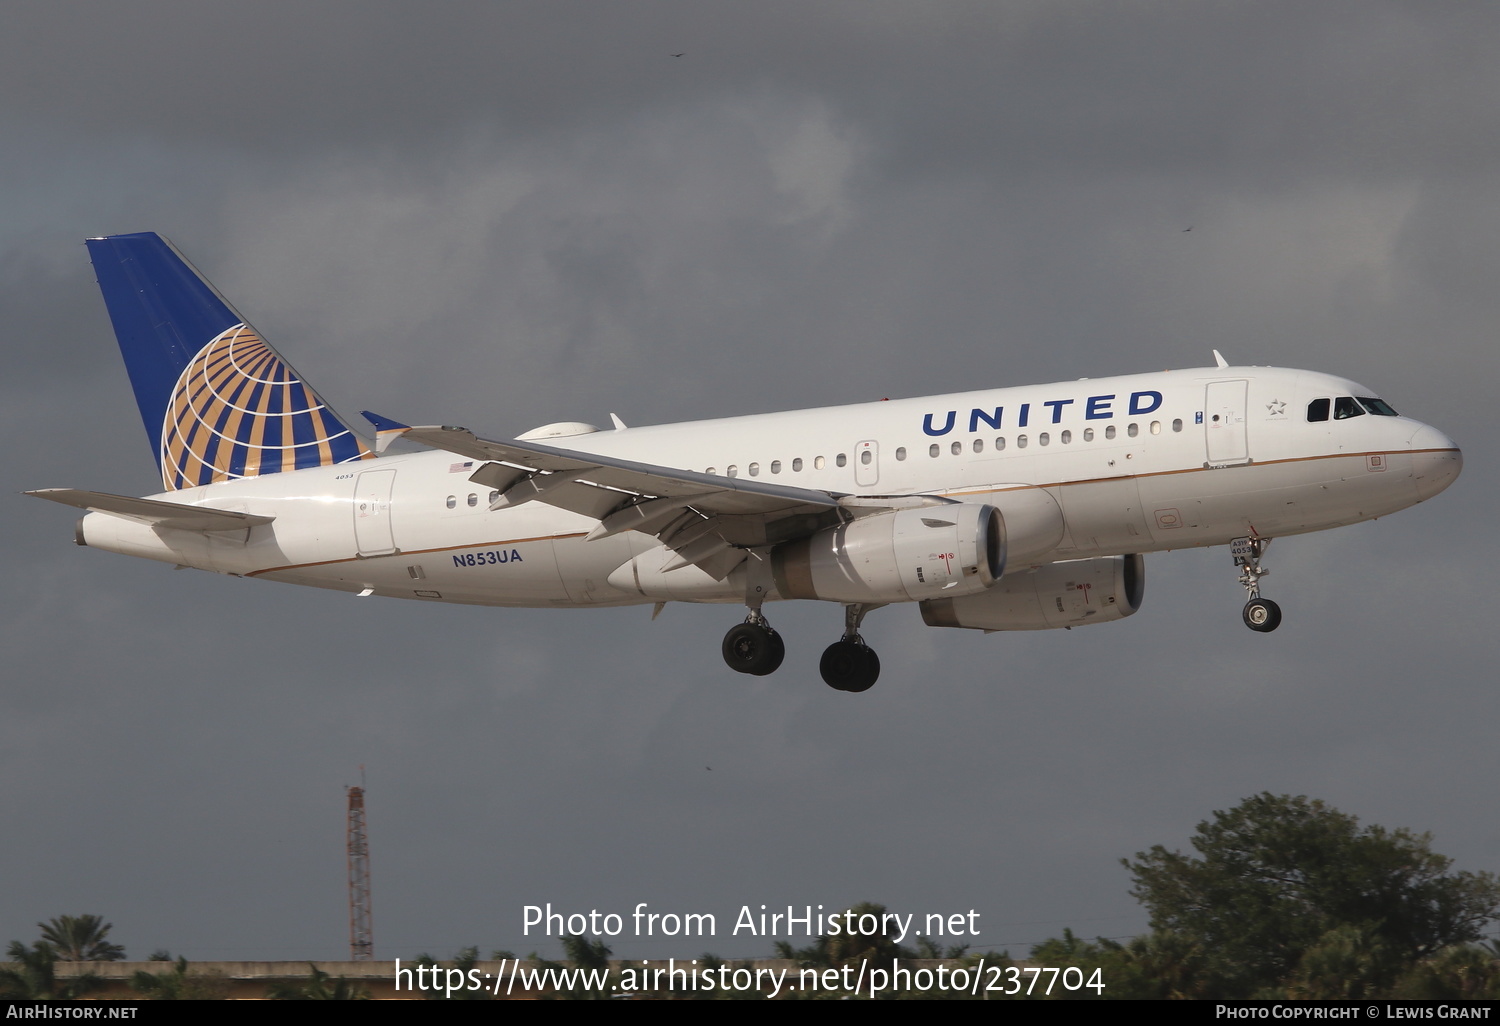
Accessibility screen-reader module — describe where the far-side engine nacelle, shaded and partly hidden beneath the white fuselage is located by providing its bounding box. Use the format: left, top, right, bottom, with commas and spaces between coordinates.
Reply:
921, 555, 1146, 630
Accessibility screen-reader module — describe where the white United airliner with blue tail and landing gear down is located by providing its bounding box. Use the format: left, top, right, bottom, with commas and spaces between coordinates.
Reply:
29, 233, 1463, 693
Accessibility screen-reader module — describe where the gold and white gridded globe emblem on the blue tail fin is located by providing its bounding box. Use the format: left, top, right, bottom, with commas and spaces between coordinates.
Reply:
161, 324, 374, 491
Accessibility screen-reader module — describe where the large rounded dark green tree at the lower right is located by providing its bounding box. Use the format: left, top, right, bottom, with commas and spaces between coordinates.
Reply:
1122, 794, 1500, 998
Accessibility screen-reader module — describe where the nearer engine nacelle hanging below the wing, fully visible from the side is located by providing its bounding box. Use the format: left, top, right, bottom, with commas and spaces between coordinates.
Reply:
771, 503, 1005, 603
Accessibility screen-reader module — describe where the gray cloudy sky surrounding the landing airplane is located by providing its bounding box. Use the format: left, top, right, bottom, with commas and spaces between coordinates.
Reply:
0, 0, 1500, 959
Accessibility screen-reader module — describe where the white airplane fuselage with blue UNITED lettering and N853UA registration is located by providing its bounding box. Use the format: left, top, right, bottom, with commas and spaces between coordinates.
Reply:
80, 368, 1461, 606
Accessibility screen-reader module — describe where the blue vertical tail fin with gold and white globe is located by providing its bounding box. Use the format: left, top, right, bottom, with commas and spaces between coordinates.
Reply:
89, 233, 374, 491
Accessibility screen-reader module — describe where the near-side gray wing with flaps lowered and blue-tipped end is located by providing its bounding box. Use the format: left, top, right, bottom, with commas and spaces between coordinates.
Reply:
393, 428, 918, 581
